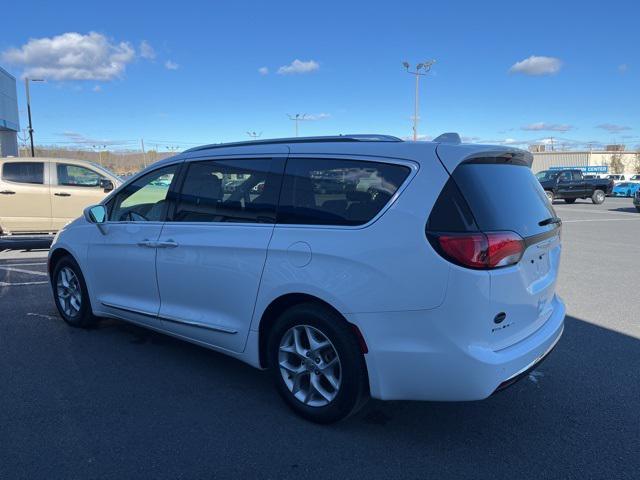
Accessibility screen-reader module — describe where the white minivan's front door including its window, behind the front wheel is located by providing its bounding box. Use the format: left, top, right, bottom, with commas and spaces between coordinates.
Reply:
88, 165, 178, 326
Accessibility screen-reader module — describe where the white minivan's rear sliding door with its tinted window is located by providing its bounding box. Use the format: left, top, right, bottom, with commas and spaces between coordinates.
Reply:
157, 155, 285, 352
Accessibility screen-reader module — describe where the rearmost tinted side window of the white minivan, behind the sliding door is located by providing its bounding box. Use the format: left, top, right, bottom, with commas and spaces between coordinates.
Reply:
278, 158, 411, 225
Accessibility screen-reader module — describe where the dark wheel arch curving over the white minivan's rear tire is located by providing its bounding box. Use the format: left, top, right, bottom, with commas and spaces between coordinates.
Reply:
258, 293, 367, 368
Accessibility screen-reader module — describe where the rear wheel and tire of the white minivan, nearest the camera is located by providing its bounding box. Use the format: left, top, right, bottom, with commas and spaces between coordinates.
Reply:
268, 303, 368, 423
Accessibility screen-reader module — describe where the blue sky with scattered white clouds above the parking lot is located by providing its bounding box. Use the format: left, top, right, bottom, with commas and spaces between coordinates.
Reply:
0, 0, 640, 149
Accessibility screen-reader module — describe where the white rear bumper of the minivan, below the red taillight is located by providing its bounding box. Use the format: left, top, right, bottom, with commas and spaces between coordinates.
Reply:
347, 296, 565, 401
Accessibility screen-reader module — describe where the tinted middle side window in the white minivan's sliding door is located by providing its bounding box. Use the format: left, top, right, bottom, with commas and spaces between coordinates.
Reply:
172, 158, 280, 223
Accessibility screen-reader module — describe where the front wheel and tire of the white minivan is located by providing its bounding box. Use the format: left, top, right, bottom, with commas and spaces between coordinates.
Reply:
51, 256, 97, 328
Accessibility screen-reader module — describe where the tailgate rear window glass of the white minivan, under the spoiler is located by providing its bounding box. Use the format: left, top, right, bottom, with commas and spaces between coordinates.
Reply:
453, 163, 556, 237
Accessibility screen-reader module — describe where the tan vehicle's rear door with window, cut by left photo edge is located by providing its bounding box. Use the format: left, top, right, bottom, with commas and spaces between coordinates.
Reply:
0, 160, 51, 233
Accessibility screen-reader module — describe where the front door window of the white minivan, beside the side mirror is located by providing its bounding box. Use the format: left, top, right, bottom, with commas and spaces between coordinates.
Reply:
109, 165, 178, 222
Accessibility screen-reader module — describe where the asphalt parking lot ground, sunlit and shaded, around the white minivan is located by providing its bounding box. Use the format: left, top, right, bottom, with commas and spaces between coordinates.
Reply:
0, 198, 640, 479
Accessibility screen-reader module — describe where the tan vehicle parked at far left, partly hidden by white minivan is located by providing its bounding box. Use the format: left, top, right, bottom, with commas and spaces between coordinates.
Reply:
0, 158, 122, 235
